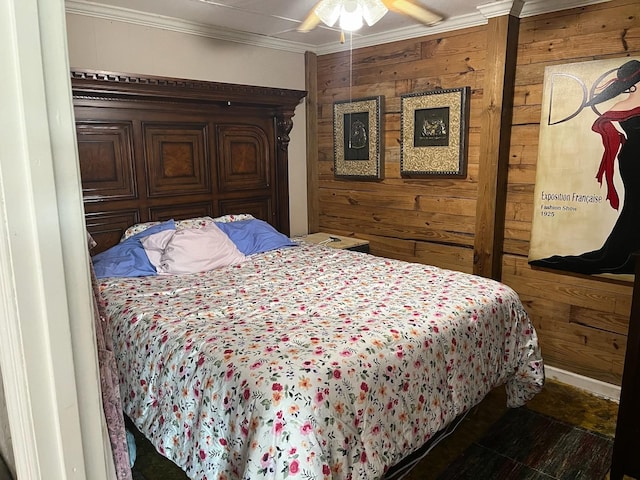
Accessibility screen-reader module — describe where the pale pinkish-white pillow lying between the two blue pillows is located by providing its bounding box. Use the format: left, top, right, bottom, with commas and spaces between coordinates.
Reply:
157, 223, 246, 275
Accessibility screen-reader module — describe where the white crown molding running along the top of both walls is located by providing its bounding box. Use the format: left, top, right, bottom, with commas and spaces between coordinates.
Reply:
65, 0, 610, 55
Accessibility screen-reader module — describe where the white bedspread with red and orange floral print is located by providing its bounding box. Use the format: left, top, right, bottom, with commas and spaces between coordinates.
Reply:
101, 244, 544, 480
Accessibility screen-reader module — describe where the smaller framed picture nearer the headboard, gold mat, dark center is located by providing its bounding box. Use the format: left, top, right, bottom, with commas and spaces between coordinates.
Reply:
333, 96, 384, 180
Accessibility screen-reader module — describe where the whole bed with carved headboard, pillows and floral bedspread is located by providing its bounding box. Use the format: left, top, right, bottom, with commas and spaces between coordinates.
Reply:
72, 72, 544, 479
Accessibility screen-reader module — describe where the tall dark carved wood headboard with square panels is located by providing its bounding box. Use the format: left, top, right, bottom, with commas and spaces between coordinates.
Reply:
71, 70, 306, 253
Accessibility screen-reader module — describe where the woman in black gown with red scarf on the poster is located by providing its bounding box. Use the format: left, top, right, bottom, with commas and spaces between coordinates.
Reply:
530, 60, 640, 274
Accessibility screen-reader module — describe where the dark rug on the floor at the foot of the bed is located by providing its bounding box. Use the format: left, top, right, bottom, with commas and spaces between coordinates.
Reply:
438, 407, 613, 480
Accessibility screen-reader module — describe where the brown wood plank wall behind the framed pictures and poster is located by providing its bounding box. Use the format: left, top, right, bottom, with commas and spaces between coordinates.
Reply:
309, 0, 640, 385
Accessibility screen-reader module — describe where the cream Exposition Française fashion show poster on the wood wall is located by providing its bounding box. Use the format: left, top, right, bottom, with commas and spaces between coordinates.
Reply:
529, 57, 640, 279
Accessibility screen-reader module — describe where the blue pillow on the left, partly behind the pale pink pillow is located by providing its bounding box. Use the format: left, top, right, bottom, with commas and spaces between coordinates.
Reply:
91, 220, 176, 278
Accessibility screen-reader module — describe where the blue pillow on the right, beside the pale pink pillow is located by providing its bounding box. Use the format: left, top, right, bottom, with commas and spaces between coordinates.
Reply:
216, 218, 298, 255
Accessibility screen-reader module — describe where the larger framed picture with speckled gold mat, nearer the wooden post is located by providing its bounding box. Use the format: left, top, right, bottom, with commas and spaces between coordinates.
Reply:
400, 87, 471, 177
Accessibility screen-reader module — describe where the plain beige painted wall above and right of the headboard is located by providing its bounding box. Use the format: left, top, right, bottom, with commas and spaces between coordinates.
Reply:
67, 13, 307, 235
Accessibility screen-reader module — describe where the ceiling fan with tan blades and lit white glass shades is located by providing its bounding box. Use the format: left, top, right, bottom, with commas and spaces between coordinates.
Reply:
297, 0, 442, 32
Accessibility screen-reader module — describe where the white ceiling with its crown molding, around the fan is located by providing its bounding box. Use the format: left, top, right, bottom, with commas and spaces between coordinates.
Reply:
65, 0, 608, 54
